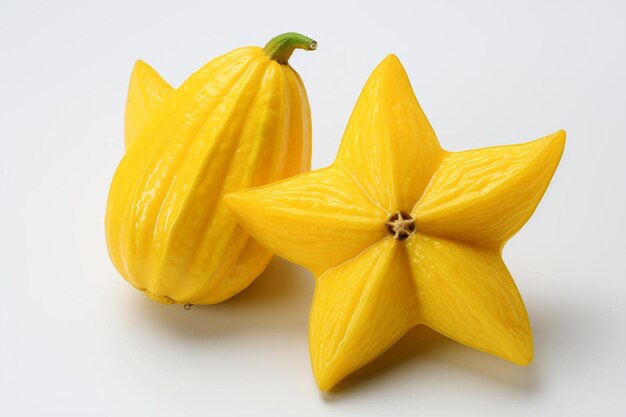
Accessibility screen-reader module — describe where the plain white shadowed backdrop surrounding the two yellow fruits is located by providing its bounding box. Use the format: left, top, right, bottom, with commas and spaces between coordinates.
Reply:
0, 0, 626, 417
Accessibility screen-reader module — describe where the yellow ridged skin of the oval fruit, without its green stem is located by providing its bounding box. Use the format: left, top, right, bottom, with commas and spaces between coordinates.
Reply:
105, 47, 311, 304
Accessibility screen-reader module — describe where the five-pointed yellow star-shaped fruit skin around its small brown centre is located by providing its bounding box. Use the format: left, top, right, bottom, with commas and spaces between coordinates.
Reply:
225, 55, 565, 390
